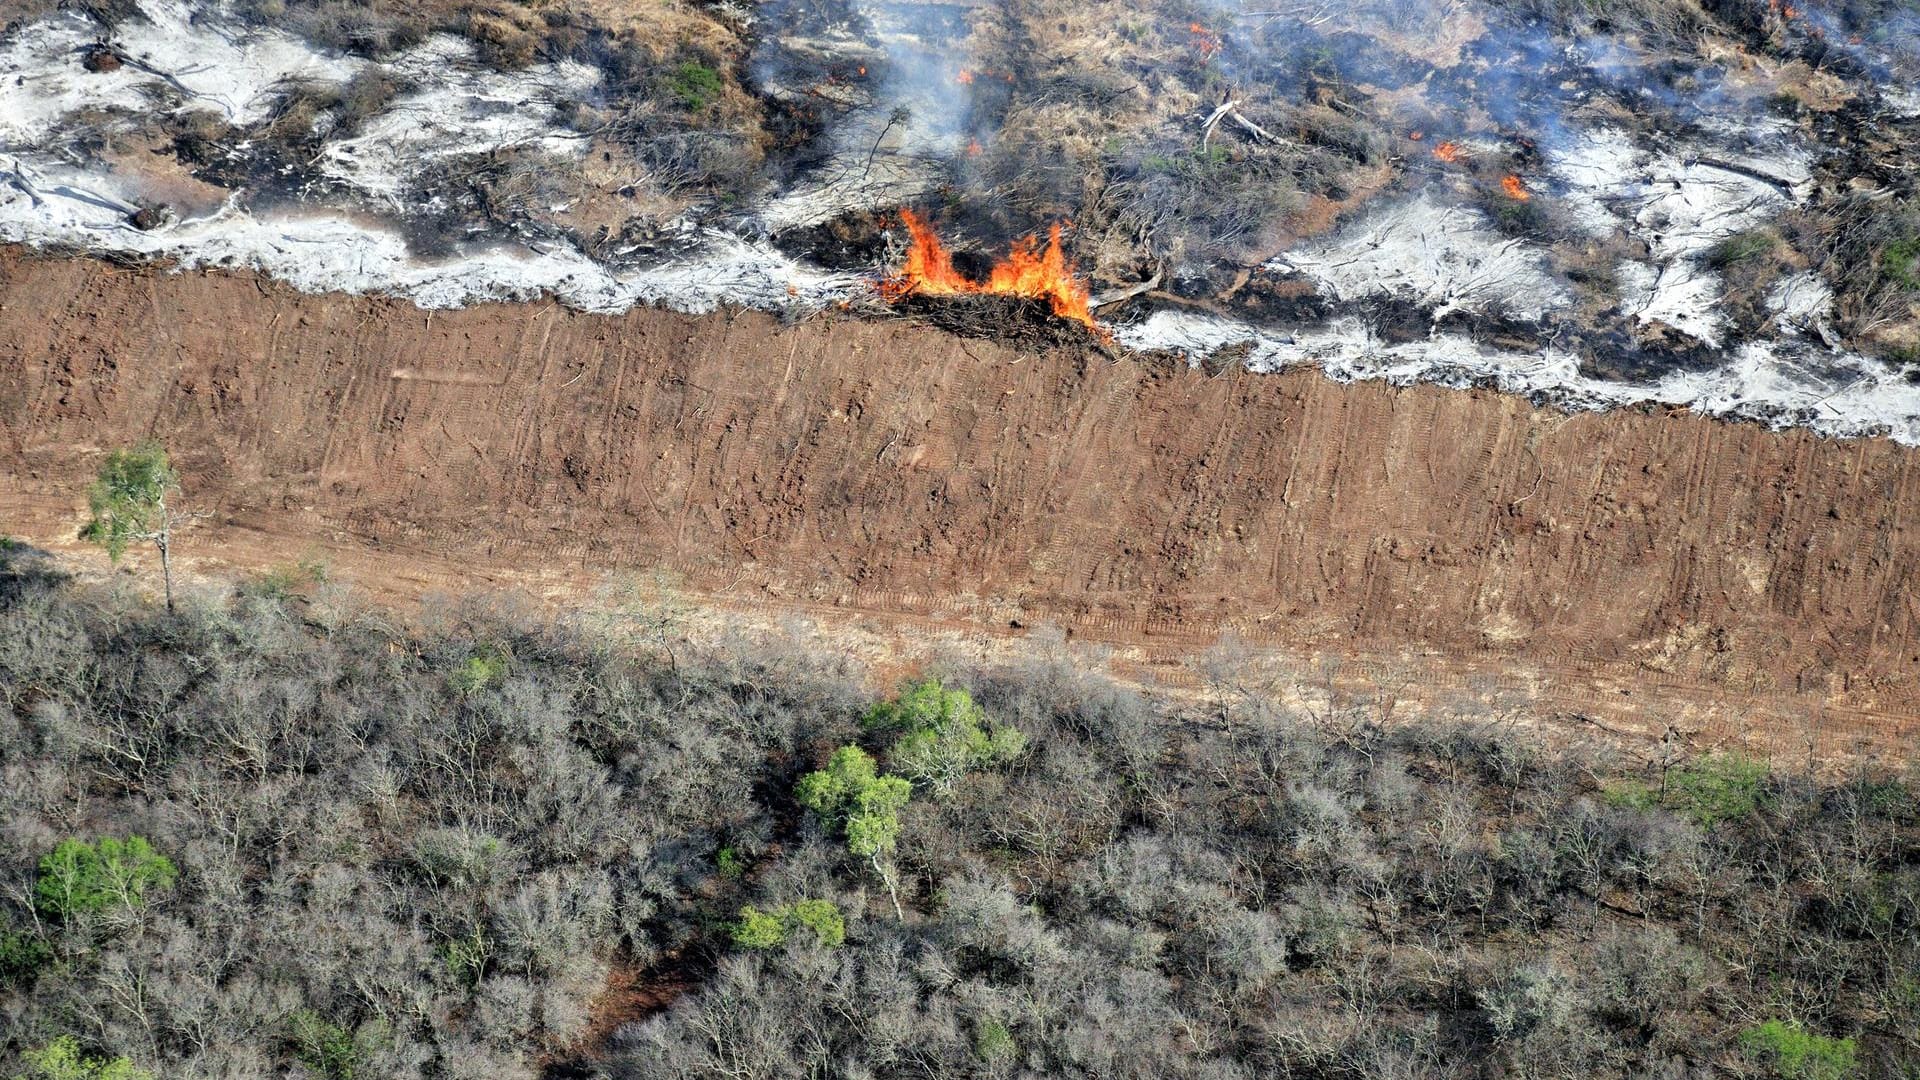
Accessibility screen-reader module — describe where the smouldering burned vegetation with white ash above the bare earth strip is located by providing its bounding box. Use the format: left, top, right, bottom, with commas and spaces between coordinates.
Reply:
11, 0, 1920, 380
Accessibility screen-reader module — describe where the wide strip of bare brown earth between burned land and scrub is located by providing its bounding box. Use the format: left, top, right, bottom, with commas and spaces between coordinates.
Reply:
0, 252, 1920, 757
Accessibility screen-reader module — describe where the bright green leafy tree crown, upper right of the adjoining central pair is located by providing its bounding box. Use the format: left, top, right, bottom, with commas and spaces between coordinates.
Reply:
866, 678, 1027, 798
